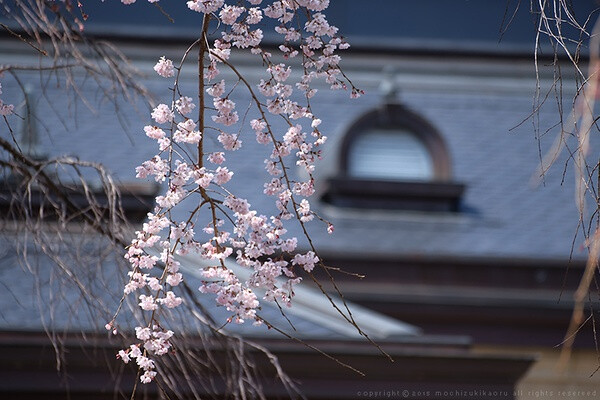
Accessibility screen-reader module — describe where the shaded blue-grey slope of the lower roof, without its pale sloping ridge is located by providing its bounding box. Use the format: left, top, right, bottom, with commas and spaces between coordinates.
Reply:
0, 239, 352, 339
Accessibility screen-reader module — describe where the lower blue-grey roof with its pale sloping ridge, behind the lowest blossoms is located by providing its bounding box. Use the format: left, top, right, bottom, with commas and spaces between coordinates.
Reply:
0, 239, 419, 340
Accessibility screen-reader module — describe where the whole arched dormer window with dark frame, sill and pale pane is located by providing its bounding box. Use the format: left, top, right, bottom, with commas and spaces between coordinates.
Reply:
322, 104, 464, 212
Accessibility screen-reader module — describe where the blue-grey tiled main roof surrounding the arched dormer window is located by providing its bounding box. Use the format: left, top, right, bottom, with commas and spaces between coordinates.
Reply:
3, 53, 585, 260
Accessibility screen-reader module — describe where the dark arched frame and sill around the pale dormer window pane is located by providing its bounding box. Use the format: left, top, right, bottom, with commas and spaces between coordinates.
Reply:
321, 104, 465, 213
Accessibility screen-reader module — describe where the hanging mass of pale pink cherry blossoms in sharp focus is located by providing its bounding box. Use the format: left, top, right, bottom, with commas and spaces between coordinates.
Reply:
113, 0, 362, 383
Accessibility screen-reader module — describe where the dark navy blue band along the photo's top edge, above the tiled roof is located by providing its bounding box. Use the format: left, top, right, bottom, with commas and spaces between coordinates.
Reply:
5, 0, 598, 53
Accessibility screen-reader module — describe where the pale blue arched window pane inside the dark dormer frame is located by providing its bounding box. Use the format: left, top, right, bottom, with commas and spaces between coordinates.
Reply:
348, 129, 434, 181
